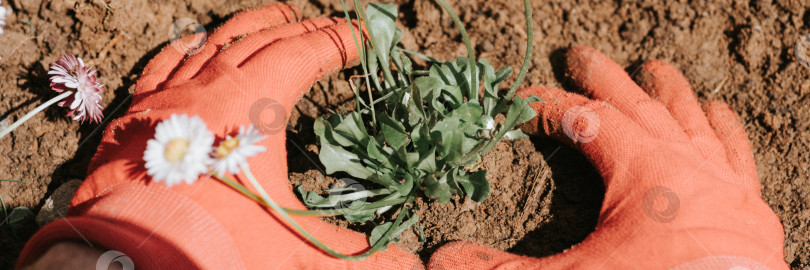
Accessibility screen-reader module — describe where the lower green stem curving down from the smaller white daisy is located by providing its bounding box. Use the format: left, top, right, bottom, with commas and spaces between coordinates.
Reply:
239, 165, 394, 261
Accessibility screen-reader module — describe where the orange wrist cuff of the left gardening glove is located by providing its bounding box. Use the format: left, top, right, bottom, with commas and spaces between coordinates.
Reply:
17, 180, 245, 269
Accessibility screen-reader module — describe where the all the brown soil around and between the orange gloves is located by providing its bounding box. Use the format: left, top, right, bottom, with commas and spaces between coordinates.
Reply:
0, 0, 810, 269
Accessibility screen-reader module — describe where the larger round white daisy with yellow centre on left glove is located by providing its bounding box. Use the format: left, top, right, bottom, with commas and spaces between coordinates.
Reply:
143, 114, 214, 186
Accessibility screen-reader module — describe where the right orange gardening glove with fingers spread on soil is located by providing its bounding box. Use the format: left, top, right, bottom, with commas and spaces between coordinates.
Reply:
428, 46, 787, 269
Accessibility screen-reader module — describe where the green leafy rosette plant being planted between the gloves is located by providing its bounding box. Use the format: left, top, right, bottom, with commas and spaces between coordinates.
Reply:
296, 0, 542, 254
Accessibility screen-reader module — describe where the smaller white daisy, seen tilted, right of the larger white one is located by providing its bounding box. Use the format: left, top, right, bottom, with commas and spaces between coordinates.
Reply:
212, 124, 267, 175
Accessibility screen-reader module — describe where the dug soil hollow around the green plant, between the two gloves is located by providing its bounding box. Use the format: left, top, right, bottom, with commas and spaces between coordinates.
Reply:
287, 70, 604, 261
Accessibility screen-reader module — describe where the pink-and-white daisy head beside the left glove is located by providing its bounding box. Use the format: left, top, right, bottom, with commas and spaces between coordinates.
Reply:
48, 54, 105, 123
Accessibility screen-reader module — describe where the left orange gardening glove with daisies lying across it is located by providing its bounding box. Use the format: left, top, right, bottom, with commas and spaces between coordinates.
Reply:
17, 4, 424, 269
